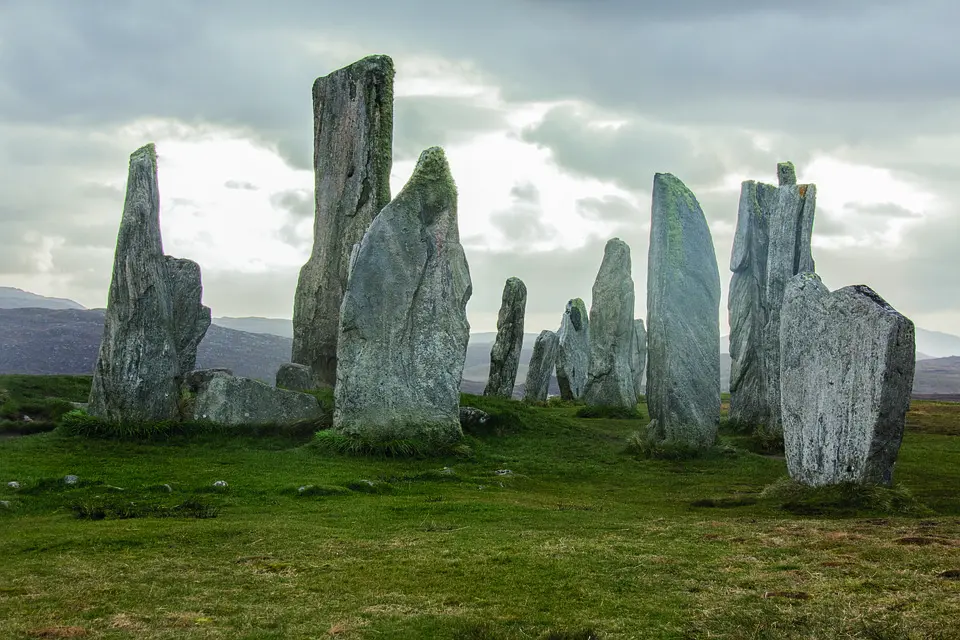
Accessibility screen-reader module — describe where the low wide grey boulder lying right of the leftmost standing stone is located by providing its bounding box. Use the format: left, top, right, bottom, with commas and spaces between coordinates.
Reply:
191, 370, 322, 426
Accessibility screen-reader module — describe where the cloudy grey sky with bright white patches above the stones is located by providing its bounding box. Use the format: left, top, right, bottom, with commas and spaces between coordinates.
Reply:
0, 0, 960, 333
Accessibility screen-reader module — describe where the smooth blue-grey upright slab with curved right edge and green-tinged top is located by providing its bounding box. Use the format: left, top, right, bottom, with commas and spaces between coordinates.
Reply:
647, 173, 720, 447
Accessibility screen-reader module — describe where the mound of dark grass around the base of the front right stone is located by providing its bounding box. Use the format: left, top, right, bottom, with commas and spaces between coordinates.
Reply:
760, 477, 930, 516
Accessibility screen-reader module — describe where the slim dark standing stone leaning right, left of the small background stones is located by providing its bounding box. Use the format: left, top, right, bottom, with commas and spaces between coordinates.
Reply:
483, 278, 527, 398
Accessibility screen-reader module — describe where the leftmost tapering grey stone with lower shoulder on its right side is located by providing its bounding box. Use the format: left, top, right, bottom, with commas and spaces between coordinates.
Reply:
89, 144, 210, 422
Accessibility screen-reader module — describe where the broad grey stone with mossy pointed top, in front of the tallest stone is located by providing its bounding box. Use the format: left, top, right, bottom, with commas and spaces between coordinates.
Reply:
334, 147, 473, 441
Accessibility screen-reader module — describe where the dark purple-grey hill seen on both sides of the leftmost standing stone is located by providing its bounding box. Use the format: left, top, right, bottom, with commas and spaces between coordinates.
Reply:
0, 308, 291, 384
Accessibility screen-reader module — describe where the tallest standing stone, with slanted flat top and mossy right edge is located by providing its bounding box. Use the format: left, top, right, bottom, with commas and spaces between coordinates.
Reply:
291, 56, 394, 387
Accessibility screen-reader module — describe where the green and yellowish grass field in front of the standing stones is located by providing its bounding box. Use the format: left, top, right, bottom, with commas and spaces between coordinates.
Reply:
0, 377, 960, 640
